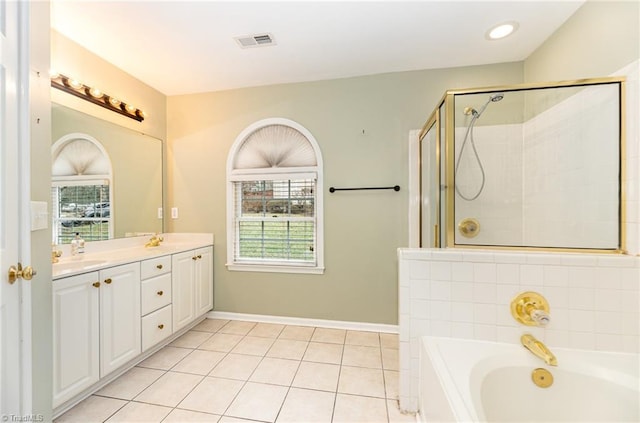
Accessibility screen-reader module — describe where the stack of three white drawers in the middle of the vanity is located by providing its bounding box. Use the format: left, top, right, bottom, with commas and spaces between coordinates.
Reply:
141, 256, 173, 351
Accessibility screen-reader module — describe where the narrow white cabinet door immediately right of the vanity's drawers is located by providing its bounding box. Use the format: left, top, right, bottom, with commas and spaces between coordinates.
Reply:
171, 251, 197, 332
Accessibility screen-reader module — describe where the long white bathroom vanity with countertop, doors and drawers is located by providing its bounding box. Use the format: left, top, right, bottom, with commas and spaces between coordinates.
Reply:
53, 234, 213, 413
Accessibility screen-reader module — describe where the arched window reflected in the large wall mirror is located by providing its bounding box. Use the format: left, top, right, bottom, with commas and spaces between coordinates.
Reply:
51, 133, 113, 244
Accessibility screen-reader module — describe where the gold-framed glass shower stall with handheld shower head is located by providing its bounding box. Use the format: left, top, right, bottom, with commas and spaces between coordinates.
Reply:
417, 78, 625, 253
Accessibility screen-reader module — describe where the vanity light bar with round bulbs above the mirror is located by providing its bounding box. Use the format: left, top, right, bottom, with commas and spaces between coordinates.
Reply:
50, 72, 146, 122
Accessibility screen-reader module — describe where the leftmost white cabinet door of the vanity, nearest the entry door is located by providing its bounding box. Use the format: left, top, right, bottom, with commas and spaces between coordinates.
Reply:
53, 272, 100, 407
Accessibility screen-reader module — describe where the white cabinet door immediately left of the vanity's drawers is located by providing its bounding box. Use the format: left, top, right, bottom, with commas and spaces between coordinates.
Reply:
100, 263, 142, 377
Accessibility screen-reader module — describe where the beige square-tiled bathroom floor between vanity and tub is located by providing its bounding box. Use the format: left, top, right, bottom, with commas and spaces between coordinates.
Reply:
56, 319, 415, 423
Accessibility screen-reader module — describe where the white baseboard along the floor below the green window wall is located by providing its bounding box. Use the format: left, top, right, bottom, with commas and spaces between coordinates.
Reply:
207, 311, 398, 333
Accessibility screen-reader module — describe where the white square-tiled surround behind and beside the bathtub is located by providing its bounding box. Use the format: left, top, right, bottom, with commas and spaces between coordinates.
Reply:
398, 249, 640, 411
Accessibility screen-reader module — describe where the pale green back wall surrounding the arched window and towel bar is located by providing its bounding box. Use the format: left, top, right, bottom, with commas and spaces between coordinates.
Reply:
167, 63, 522, 324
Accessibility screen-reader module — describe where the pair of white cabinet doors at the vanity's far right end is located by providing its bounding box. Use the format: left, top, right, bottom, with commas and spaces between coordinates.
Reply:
171, 247, 213, 331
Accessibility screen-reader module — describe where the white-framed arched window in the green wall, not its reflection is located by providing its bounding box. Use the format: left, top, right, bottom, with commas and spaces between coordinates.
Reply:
227, 118, 324, 273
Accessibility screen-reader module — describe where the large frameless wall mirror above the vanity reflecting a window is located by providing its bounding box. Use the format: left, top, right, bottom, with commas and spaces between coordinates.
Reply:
51, 104, 163, 244
